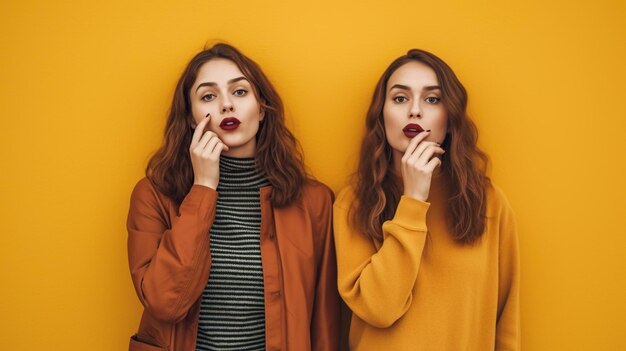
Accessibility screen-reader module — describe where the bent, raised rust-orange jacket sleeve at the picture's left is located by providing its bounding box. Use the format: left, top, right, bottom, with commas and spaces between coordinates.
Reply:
127, 178, 217, 322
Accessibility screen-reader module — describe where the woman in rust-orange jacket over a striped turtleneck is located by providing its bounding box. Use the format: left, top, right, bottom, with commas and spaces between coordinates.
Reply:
127, 44, 339, 351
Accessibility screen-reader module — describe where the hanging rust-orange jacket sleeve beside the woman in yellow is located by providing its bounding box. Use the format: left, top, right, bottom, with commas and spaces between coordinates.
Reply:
311, 187, 341, 351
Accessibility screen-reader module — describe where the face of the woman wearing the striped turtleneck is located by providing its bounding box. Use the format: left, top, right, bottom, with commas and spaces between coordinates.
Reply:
189, 58, 264, 157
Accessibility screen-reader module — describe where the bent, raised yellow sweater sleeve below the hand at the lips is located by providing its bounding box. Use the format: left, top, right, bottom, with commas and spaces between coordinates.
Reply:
334, 191, 430, 328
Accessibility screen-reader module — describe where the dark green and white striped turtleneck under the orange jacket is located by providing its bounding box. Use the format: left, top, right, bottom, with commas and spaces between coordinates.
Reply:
196, 155, 270, 351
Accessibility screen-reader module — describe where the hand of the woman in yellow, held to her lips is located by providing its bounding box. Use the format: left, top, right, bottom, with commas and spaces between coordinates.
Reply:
402, 131, 445, 201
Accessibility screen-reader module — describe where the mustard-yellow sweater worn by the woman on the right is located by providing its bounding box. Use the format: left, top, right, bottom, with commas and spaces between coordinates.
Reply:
334, 178, 520, 351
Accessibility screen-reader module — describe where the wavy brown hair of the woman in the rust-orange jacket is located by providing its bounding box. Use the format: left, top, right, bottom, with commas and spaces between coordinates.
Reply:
146, 43, 307, 207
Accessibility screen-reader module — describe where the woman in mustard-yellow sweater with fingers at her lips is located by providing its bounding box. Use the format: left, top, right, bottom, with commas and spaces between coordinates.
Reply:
334, 49, 520, 351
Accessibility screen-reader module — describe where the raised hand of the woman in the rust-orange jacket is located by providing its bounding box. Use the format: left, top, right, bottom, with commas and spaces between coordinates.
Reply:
189, 115, 228, 190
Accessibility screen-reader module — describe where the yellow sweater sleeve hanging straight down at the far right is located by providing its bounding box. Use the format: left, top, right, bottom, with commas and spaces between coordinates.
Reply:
496, 194, 520, 351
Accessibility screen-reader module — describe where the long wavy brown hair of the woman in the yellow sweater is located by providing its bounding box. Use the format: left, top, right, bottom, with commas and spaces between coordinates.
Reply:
350, 49, 491, 243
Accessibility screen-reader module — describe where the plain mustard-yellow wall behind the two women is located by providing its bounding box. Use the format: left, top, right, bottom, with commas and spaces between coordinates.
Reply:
0, 0, 626, 350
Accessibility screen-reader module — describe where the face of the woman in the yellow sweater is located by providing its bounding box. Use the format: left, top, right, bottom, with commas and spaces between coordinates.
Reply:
383, 61, 448, 158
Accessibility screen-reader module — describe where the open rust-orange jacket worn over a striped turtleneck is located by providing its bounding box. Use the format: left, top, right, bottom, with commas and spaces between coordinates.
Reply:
127, 178, 339, 351
